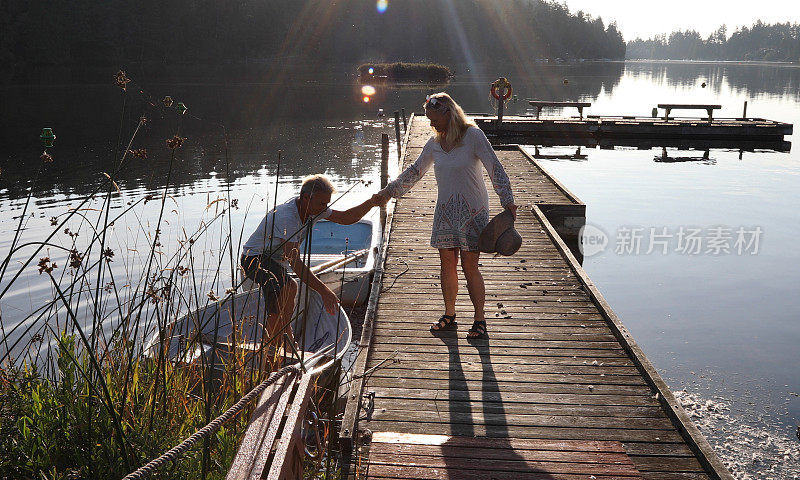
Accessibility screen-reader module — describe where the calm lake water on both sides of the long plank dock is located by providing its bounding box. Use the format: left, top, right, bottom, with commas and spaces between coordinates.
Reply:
0, 62, 800, 478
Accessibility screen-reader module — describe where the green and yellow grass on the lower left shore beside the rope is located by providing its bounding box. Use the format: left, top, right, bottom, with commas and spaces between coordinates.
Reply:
0, 334, 262, 480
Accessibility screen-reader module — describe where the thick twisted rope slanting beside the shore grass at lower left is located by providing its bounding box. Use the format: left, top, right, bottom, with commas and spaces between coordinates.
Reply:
123, 364, 300, 480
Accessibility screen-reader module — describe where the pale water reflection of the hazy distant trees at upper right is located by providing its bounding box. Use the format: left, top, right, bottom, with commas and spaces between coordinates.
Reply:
625, 62, 800, 98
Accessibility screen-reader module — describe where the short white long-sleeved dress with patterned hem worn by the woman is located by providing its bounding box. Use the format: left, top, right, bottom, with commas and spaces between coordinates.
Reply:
385, 127, 514, 251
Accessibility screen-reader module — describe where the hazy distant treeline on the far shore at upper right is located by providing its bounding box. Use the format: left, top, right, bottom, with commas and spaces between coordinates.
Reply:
625, 20, 800, 63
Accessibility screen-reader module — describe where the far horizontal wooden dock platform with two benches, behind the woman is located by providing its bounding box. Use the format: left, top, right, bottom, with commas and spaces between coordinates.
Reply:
473, 115, 793, 142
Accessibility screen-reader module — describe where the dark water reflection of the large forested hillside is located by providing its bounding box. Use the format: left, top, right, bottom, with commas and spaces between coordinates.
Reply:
0, 62, 624, 199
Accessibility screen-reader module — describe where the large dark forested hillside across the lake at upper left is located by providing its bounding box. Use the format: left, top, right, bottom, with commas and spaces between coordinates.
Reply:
0, 0, 625, 79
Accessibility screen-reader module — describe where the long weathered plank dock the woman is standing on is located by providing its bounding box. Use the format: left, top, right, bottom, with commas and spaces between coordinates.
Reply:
341, 116, 732, 480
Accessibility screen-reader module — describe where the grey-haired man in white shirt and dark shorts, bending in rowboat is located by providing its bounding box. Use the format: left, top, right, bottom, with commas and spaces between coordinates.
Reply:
241, 174, 386, 344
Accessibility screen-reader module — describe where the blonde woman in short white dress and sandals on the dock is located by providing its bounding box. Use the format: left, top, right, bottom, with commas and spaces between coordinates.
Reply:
380, 93, 517, 339
